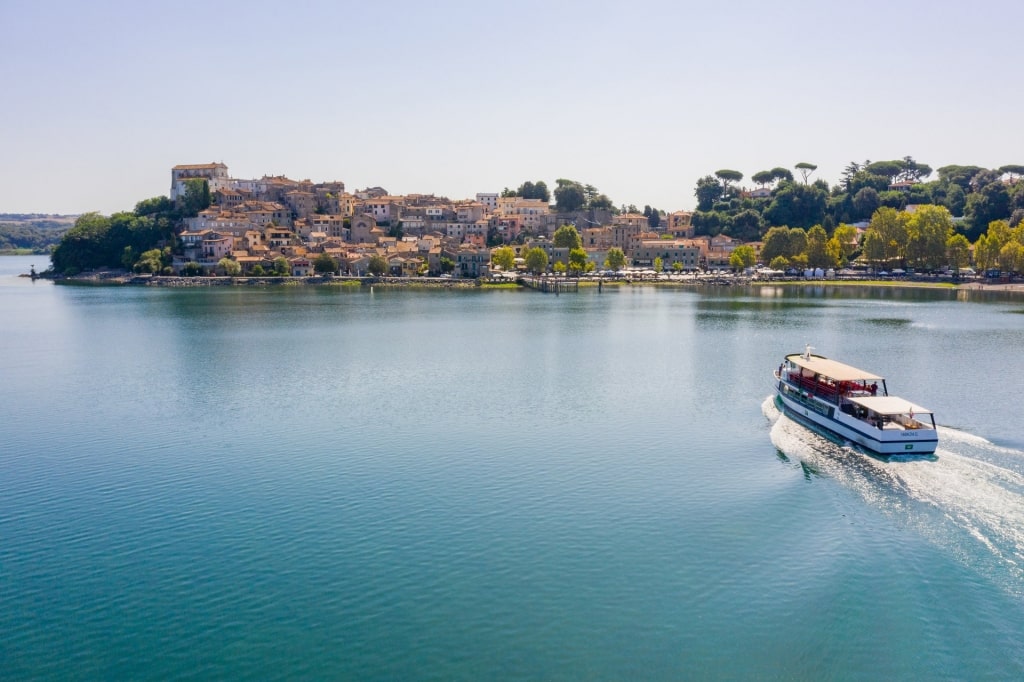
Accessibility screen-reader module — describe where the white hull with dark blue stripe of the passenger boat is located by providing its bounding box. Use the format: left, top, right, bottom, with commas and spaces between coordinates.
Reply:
775, 386, 939, 457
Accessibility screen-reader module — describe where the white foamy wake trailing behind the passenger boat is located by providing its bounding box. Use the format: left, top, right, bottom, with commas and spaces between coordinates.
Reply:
762, 396, 1024, 594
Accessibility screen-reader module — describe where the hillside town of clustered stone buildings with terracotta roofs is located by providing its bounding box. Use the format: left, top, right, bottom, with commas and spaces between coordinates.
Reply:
171, 163, 735, 278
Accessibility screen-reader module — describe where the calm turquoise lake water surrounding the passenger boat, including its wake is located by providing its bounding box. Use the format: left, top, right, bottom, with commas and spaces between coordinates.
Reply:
0, 258, 1024, 680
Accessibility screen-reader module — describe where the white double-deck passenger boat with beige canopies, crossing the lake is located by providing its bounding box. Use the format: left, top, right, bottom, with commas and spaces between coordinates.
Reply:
775, 346, 939, 457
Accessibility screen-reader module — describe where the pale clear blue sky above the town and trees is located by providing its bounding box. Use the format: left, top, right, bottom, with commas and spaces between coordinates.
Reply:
0, 0, 1024, 213
